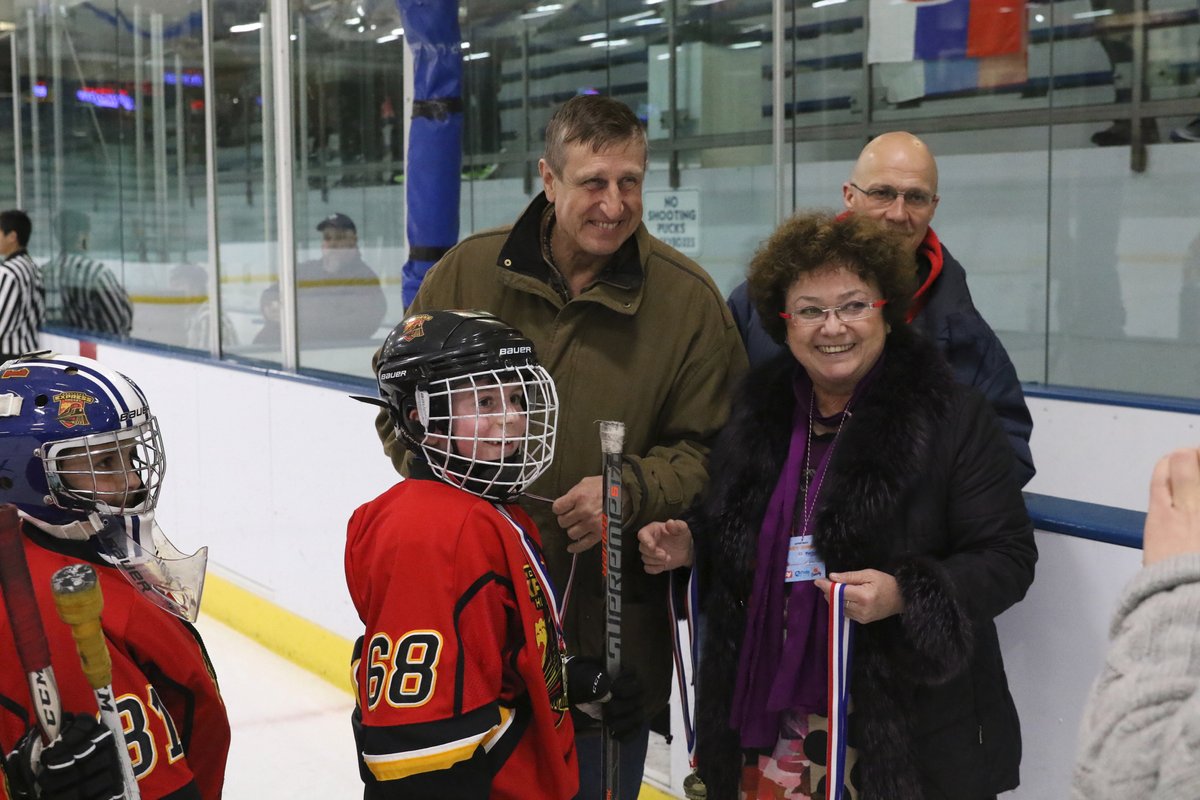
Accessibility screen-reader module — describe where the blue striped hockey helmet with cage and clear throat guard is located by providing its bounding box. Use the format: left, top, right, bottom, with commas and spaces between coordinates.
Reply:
0, 353, 208, 620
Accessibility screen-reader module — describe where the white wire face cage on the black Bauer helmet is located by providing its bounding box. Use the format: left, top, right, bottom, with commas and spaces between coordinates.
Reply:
416, 366, 558, 501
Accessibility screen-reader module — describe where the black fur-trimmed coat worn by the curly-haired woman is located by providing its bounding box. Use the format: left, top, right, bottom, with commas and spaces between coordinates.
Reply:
690, 326, 1037, 800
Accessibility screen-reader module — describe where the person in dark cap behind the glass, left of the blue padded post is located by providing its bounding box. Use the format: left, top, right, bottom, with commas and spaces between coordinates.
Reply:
254, 213, 388, 347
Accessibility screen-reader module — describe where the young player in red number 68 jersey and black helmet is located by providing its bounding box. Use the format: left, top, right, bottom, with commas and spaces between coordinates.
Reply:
346, 311, 636, 800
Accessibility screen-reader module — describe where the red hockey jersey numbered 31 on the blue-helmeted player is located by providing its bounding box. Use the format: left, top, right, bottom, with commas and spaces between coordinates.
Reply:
0, 523, 229, 800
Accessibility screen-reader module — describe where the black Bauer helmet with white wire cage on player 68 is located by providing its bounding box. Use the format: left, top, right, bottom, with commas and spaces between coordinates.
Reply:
376, 311, 558, 503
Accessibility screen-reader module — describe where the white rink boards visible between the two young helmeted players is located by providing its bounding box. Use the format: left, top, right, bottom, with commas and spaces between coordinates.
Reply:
43, 335, 388, 640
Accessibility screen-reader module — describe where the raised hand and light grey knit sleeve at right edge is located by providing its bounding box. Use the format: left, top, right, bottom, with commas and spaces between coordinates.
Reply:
1070, 449, 1200, 800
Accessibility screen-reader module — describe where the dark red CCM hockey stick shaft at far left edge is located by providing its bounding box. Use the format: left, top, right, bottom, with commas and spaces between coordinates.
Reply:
0, 503, 62, 744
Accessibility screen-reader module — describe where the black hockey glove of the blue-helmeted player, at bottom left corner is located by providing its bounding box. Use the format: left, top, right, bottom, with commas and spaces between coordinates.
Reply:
5, 714, 125, 800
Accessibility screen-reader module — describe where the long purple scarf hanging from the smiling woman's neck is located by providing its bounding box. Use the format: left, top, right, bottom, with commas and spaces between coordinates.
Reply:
730, 357, 883, 748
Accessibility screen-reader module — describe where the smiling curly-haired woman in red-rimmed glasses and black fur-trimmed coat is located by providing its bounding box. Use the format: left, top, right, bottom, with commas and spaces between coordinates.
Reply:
638, 213, 1037, 800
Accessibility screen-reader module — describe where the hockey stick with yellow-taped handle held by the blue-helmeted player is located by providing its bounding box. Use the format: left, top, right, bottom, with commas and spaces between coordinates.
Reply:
50, 564, 142, 800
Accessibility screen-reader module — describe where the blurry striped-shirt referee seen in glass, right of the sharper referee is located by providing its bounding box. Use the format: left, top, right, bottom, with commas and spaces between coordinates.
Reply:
42, 209, 133, 336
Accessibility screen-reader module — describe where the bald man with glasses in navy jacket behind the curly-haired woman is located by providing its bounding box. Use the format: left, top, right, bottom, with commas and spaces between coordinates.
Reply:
728, 131, 1034, 486
